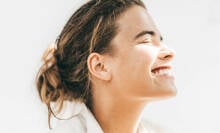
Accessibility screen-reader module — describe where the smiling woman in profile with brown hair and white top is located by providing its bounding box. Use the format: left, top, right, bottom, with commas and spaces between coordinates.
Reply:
36, 0, 176, 133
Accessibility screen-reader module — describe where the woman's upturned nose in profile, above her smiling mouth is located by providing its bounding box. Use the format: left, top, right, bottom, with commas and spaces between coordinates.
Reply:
158, 45, 175, 61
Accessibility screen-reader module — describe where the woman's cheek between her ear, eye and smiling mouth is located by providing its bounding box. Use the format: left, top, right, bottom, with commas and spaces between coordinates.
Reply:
114, 45, 158, 87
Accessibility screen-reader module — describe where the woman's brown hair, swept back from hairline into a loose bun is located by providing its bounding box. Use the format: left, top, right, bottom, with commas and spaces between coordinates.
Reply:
36, 0, 145, 127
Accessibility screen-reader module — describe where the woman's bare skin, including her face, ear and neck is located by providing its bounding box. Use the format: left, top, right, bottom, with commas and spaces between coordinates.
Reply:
87, 6, 176, 133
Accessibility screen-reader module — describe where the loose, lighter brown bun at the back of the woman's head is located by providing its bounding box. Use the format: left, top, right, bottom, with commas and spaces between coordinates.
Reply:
36, 45, 65, 126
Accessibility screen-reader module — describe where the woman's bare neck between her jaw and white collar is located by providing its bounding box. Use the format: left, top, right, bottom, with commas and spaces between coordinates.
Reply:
92, 87, 146, 133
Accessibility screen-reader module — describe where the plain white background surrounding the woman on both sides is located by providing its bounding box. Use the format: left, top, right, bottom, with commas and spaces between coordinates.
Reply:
0, 0, 220, 133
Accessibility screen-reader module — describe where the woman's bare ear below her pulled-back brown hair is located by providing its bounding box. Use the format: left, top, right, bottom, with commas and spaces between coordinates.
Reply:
87, 53, 111, 81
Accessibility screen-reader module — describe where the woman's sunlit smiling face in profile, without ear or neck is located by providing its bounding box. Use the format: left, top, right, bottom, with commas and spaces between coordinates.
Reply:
107, 6, 176, 99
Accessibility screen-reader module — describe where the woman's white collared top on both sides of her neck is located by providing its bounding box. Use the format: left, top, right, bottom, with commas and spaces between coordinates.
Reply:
49, 102, 174, 133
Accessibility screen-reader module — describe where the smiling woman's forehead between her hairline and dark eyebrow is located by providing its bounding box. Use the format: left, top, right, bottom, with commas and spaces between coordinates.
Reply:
116, 6, 159, 40
